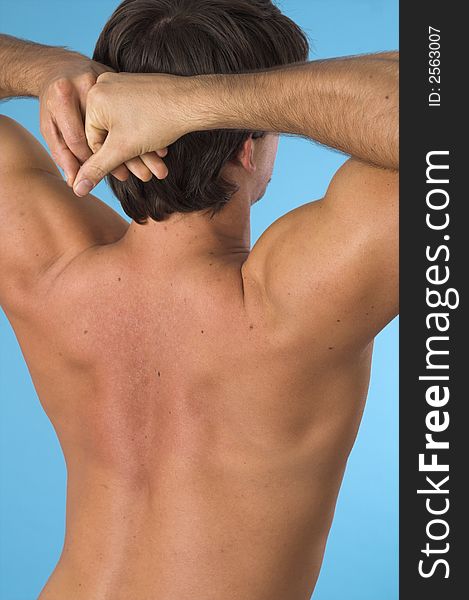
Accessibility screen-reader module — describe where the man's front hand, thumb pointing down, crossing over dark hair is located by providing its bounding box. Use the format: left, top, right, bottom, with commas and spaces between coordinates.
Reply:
73, 73, 192, 196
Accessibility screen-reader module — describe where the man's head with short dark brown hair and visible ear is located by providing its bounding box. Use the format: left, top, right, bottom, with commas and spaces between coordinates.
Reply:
93, 0, 308, 223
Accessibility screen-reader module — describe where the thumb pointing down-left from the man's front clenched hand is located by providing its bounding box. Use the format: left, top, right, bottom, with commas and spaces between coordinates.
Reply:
73, 135, 124, 197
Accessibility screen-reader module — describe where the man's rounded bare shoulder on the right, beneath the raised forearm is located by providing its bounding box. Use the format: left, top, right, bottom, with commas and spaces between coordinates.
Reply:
244, 159, 398, 348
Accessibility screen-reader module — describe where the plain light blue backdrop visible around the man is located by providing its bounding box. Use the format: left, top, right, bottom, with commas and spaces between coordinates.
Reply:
0, 0, 398, 600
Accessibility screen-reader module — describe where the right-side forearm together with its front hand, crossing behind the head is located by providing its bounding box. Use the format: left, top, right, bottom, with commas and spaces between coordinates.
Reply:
74, 52, 398, 189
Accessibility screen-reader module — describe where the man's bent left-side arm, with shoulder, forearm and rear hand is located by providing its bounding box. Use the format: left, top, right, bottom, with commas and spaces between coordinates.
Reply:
0, 35, 131, 312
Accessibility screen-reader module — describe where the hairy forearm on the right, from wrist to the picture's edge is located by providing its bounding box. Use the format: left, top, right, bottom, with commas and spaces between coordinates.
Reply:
190, 53, 399, 169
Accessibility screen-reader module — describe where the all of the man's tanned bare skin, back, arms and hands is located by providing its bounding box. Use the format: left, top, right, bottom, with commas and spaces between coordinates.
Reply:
0, 30, 398, 600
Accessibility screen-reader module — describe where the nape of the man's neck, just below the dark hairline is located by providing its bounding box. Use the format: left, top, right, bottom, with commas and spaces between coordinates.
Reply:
125, 193, 251, 260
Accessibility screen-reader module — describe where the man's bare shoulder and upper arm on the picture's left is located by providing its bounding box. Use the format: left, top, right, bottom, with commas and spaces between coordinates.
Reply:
0, 116, 128, 311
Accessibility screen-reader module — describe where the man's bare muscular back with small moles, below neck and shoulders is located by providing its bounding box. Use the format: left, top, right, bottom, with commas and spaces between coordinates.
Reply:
11, 225, 371, 600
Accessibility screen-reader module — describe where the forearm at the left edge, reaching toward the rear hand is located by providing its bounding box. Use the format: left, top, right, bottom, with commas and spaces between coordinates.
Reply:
0, 34, 78, 99
